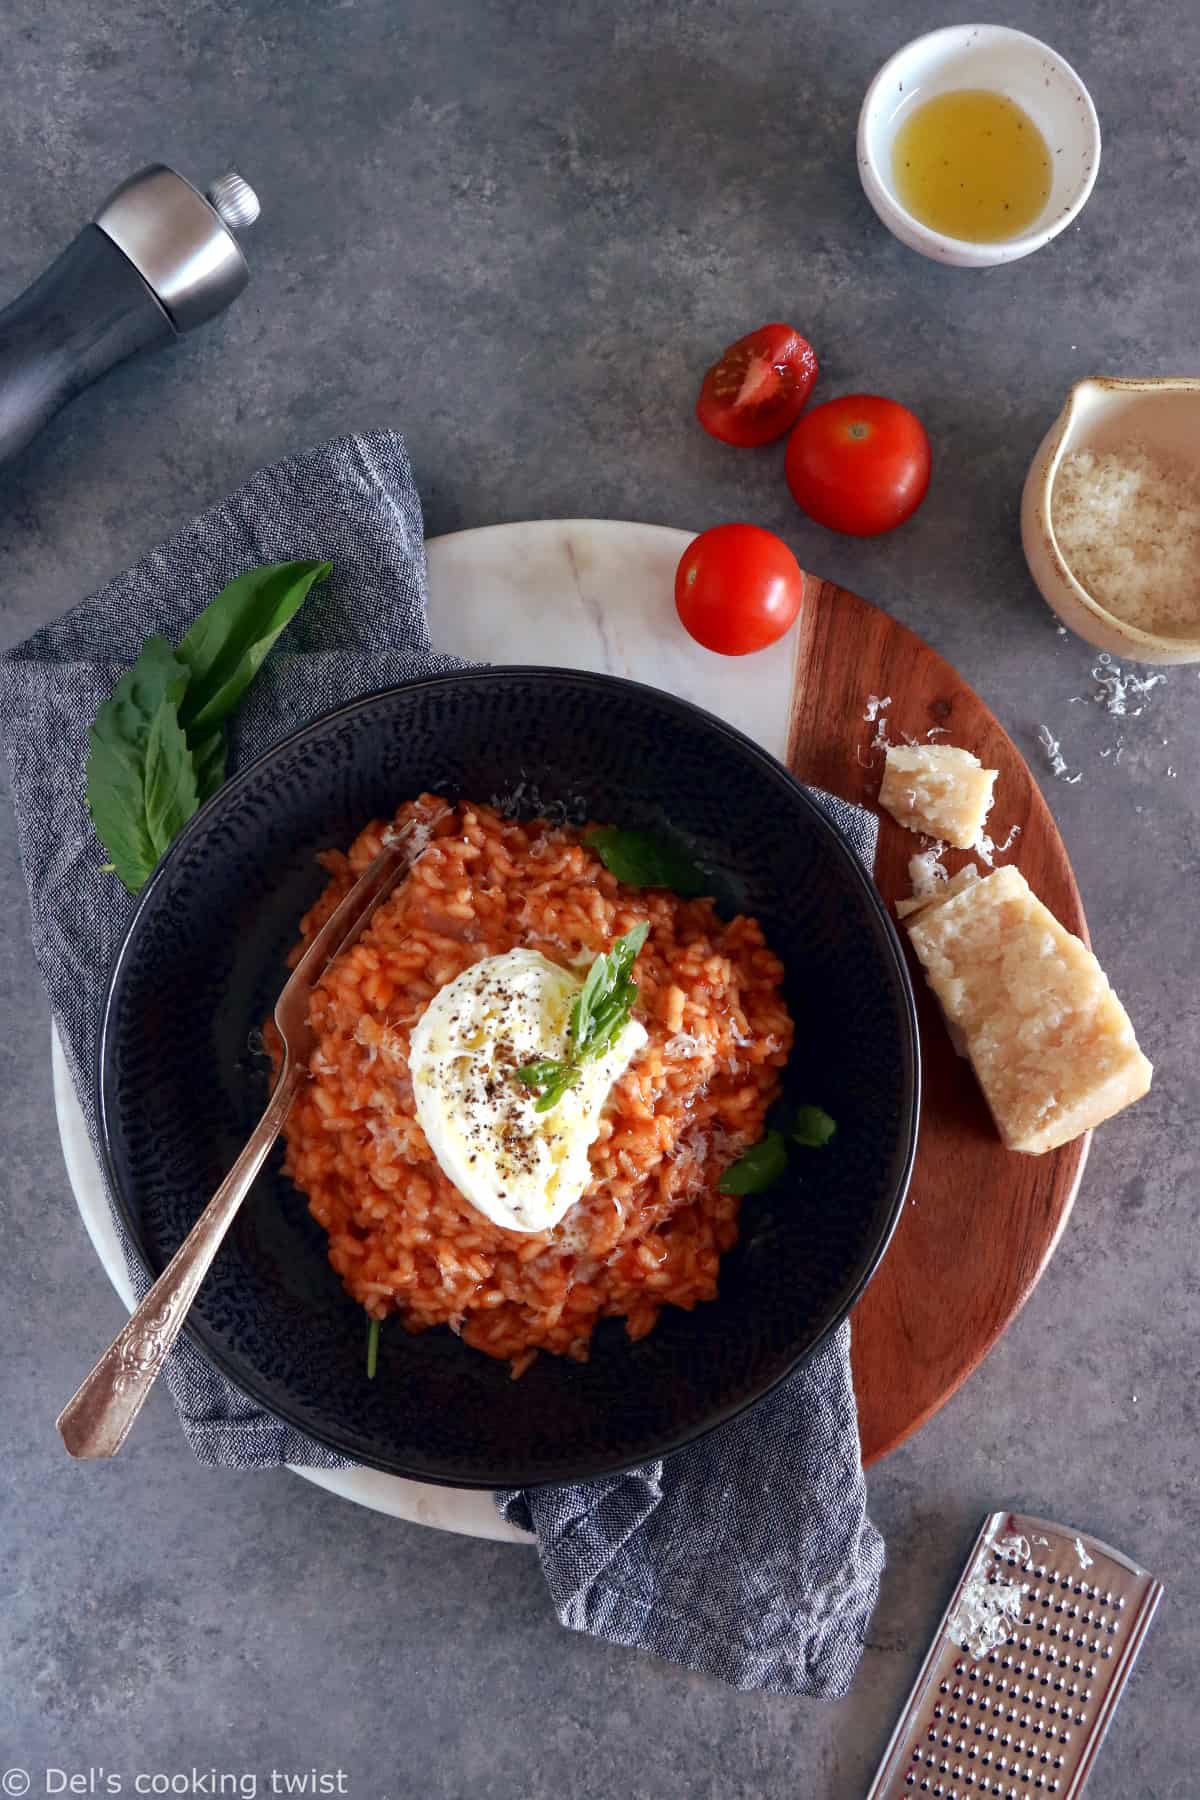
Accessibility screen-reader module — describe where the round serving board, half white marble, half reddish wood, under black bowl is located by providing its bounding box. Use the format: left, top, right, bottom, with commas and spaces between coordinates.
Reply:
54, 520, 1087, 1544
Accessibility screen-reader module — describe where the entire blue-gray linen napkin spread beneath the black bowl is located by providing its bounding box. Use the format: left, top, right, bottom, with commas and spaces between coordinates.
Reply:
0, 432, 883, 1697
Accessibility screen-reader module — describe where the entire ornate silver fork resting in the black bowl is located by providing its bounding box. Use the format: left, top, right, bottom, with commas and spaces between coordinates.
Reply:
58, 821, 437, 1456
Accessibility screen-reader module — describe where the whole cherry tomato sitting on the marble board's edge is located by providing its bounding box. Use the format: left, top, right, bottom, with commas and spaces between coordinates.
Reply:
675, 526, 804, 657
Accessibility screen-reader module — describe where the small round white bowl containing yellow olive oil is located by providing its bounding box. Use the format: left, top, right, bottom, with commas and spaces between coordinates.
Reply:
858, 25, 1099, 268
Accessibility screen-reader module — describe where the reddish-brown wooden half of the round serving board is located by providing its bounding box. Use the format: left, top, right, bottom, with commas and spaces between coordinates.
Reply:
788, 576, 1090, 1462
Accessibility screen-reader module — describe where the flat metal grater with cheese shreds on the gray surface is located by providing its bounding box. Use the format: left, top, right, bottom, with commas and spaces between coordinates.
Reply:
867, 1512, 1162, 1800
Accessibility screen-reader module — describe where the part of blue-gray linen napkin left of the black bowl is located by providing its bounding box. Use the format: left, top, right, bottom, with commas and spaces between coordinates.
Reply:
0, 432, 464, 1469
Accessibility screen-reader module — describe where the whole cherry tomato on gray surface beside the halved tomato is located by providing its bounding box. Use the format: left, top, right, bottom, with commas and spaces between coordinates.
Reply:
784, 394, 930, 538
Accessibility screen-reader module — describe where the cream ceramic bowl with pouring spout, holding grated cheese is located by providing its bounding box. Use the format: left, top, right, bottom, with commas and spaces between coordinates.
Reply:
1020, 374, 1200, 662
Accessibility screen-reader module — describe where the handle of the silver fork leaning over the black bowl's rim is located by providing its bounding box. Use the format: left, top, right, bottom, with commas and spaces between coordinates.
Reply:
58, 1058, 304, 1456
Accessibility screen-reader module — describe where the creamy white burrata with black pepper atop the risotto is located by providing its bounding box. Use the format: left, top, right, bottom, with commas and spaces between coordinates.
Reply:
408, 950, 646, 1231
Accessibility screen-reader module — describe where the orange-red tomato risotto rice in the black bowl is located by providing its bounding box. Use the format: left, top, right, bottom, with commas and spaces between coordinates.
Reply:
275, 794, 792, 1375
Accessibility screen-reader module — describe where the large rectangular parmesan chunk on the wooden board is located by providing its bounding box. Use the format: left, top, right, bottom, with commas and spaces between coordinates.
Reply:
909, 866, 1153, 1156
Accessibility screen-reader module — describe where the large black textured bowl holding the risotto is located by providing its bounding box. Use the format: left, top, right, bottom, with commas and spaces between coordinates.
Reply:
99, 668, 919, 1487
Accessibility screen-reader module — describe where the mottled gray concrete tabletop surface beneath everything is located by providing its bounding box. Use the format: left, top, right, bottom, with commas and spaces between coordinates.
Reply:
0, 0, 1200, 1800
